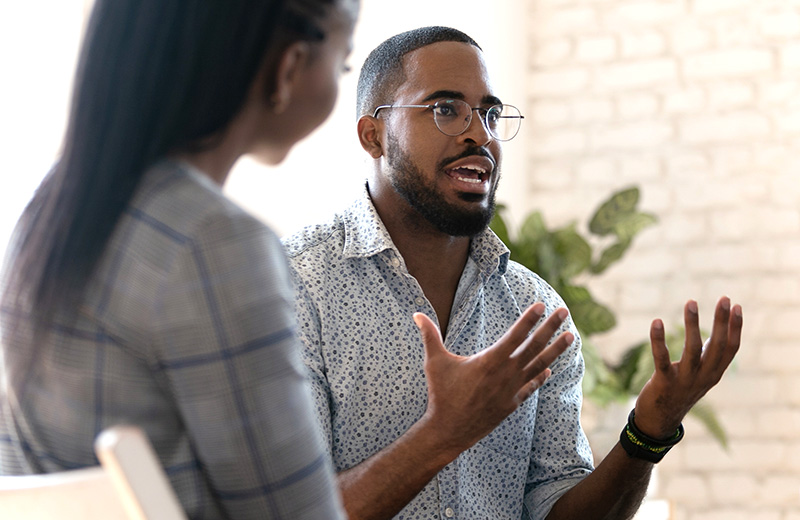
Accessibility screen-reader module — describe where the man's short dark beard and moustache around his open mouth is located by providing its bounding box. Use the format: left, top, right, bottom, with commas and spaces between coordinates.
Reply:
386, 132, 499, 237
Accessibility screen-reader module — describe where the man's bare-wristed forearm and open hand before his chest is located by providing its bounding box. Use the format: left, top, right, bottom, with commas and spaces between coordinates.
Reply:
337, 303, 575, 520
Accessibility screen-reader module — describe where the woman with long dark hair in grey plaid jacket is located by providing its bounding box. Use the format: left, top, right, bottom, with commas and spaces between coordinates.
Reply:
0, 0, 358, 519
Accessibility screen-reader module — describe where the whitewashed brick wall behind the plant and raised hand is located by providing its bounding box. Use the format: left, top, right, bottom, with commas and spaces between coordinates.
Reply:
524, 0, 800, 520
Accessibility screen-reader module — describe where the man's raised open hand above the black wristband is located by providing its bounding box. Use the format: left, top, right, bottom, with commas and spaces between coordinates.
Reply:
635, 297, 742, 439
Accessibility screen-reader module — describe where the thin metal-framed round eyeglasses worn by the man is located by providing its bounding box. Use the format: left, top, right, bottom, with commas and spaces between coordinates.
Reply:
372, 99, 524, 141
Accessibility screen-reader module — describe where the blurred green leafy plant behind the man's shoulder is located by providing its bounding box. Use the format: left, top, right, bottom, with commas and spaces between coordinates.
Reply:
491, 187, 728, 448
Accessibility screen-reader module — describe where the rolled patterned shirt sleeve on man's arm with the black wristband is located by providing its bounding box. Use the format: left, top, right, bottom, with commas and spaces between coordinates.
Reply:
523, 286, 594, 520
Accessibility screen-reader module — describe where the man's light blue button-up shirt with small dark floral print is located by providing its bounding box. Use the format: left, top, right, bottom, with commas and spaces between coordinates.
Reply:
284, 190, 592, 520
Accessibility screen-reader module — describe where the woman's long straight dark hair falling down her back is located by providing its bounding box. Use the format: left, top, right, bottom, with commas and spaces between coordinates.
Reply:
2, 0, 334, 340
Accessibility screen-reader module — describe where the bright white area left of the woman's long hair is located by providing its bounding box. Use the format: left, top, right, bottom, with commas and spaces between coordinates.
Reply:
0, 0, 84, 257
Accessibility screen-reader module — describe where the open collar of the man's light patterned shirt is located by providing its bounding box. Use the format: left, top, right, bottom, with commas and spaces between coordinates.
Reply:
343, 184, 510, 276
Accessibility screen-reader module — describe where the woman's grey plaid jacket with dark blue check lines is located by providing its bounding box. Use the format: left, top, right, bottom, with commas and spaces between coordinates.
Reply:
0, 161, 343, 520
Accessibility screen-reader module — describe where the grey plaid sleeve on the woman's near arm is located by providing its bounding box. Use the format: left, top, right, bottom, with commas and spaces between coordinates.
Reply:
154, 214, 344, 519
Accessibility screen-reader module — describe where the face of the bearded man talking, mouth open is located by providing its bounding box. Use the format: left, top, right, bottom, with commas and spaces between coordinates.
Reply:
381, 42, 501, 236
